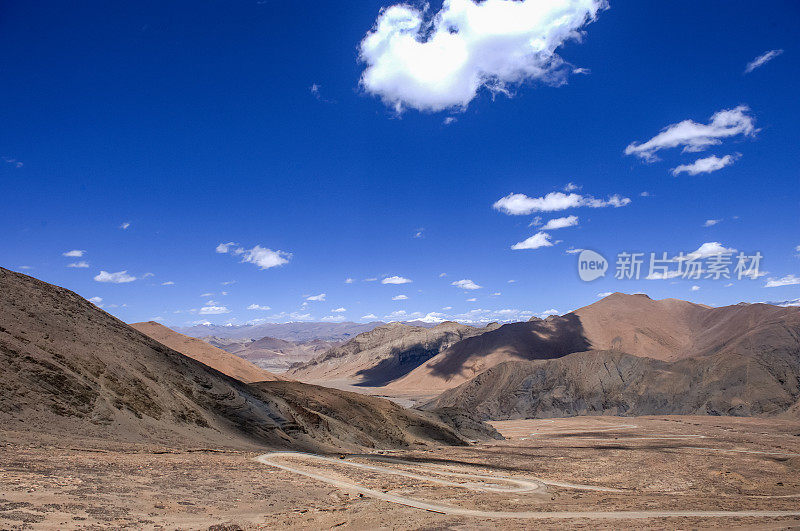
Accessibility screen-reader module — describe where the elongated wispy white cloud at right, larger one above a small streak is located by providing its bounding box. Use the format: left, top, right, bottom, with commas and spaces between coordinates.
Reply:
625, 105, 758, 162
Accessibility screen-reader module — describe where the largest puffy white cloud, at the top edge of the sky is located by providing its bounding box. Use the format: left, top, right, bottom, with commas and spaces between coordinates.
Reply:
359, 0, 606, 112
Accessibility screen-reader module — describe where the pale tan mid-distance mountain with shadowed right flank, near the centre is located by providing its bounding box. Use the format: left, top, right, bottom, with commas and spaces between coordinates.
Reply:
287, 321, 497, 386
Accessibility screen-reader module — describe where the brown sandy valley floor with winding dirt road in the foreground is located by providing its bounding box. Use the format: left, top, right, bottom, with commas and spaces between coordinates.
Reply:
0, 416, 800, 529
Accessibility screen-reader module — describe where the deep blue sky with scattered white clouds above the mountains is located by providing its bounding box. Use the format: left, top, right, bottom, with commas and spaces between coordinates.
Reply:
0, 0, 800, 325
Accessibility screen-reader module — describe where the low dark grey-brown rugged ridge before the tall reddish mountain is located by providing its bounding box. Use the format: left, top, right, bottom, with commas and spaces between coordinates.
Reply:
425, 348, 800, 420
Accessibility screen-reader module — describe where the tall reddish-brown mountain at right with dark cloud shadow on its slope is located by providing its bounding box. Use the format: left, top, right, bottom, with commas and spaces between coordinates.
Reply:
389, 293, 800, 391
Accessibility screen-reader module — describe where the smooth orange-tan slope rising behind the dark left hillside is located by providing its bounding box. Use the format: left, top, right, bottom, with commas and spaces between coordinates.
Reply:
130, 321, 282, 383
